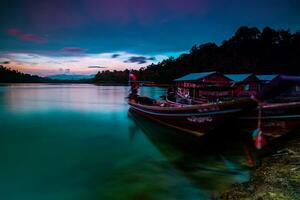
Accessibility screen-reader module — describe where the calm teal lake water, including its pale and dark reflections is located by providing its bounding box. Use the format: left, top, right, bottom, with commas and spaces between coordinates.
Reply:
0, 84, 255, 200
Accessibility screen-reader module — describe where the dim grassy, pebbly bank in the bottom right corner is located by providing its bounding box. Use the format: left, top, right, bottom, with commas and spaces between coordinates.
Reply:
219, 131, 300, 200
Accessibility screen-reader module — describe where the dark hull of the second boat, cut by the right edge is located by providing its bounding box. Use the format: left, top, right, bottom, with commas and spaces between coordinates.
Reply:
239, 102, 300, 140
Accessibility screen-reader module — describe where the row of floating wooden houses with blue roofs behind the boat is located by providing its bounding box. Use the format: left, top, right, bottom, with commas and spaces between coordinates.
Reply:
174, 71, 282, 98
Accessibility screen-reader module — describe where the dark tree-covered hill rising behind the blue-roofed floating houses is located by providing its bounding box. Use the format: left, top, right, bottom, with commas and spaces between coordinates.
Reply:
94, 27, 300, 83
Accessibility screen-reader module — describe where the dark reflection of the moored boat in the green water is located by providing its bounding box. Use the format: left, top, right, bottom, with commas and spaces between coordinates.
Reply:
129, 112, 256, 195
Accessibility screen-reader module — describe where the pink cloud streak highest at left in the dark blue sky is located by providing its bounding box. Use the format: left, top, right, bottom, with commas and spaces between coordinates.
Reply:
6, 28, 48, 44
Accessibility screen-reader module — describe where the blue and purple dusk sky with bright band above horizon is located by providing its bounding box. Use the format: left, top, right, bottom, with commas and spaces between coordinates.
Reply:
0, 0, 300, 76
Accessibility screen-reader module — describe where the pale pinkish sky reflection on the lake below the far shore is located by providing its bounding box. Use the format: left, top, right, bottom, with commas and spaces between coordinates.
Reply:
2, 84, 128, 112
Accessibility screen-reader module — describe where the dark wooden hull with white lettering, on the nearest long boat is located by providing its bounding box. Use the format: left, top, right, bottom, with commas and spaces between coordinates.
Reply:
129, 99, 254, 136
